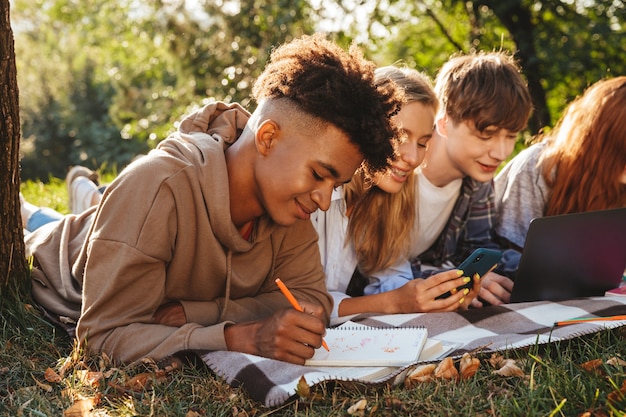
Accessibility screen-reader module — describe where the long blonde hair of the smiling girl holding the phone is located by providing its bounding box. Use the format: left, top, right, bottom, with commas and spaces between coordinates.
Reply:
344, 66, 438, 275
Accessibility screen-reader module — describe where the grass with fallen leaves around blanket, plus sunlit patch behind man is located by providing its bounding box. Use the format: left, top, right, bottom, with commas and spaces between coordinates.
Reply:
8, 180, 626, 417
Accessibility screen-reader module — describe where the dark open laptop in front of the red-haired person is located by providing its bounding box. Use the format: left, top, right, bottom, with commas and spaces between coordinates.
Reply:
511, 207, 626, 303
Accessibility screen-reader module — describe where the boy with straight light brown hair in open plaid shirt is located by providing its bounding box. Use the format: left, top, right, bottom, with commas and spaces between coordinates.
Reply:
413, 51, 532, 306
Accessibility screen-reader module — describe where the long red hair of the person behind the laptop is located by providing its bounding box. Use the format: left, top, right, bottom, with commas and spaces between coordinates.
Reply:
539, 76, 626, 216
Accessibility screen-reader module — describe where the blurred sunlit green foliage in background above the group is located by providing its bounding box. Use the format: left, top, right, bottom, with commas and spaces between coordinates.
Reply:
11, 0, 626, 181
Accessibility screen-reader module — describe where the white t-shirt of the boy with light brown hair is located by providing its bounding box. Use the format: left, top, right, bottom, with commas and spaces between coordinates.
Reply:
411, 167, 463, 257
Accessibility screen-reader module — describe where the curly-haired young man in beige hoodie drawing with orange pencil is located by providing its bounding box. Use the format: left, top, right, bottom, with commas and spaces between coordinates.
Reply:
26, 35, 401, 364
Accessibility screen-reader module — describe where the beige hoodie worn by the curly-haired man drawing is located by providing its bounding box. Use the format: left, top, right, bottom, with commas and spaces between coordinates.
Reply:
26, 103, 332, 362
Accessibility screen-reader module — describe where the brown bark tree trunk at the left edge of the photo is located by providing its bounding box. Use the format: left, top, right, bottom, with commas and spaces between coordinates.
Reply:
0, 0, 28, 296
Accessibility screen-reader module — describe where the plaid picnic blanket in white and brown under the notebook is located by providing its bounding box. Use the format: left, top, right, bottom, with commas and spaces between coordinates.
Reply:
197, 297, 626, 407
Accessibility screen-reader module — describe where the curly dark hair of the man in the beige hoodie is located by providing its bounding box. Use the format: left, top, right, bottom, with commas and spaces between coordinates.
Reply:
252, 33, 403, 173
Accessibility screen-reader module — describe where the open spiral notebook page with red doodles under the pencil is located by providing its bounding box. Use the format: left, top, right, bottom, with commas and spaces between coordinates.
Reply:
305, 326, 428, 367
